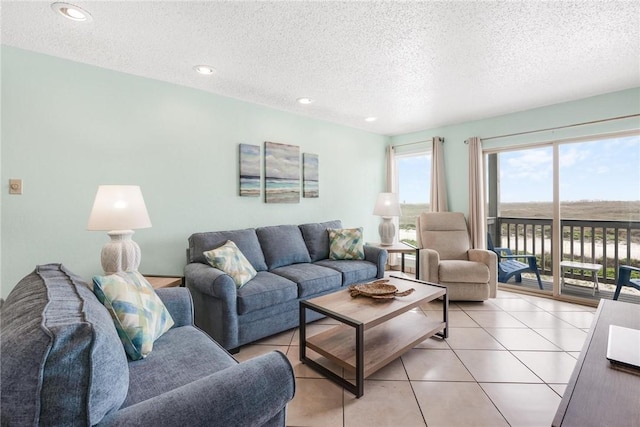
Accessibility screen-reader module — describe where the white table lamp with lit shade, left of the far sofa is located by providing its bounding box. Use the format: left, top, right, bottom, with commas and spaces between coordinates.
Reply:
87, 185, 151, 274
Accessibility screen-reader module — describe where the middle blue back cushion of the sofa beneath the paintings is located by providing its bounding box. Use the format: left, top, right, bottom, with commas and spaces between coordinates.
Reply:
256, 225, 311, 270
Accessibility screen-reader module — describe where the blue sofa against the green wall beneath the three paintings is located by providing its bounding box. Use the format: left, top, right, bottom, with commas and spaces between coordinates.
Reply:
184, 220, 387, 352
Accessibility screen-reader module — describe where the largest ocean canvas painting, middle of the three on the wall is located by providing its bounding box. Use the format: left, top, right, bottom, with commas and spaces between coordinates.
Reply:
264, 141, 300, 203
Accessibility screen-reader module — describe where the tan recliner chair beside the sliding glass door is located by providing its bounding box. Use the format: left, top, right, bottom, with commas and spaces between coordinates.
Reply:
416, 212, 498, 301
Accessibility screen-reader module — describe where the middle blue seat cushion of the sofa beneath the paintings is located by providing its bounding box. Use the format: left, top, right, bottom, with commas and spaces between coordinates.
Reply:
272, 263, 342, 298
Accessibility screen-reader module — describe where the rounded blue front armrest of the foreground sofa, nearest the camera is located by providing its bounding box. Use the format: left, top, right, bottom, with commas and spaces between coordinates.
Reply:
98, 351, 295, 426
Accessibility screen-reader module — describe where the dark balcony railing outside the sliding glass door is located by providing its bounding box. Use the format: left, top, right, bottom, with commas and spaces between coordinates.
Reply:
488, 217, 640, 284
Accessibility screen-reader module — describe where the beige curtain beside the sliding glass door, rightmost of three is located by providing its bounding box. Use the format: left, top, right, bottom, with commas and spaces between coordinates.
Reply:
467, 137, 487, 249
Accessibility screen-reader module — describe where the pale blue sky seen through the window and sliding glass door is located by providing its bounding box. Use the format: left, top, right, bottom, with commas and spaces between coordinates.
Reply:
397, 135, 640, 203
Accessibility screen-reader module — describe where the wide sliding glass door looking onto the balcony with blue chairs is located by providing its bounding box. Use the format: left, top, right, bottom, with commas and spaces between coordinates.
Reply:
485, 134, 640, 302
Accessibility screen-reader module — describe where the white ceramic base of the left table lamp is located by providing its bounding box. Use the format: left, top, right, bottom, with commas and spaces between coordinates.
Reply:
100, 230, 142, 274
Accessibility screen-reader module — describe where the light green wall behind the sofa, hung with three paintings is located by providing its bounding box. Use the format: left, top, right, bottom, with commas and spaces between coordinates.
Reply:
0, 46, 388, 297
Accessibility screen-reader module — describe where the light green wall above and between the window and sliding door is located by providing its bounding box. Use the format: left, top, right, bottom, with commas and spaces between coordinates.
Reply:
390, 88, 640, 214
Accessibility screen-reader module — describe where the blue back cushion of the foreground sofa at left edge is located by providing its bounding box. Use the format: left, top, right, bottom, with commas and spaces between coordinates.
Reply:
0, 264, 129, 425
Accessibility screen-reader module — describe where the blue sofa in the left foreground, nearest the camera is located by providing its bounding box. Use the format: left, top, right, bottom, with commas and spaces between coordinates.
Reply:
0, 264, 295, 427
